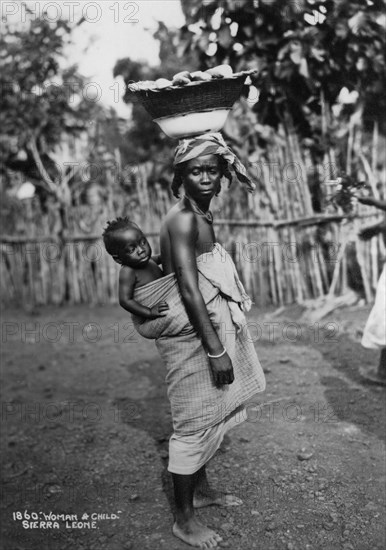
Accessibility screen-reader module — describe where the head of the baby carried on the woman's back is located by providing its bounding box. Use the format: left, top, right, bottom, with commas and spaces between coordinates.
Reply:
102, 217, 152, 268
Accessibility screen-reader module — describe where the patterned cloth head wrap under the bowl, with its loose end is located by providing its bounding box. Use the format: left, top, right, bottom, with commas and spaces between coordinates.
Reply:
174, 132, 256, 192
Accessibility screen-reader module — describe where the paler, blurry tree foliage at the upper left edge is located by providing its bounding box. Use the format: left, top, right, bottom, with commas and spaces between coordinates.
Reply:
0, 14, 105, 207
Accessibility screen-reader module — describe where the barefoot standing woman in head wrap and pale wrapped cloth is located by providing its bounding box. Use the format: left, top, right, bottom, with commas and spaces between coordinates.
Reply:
157, 134, 265, 548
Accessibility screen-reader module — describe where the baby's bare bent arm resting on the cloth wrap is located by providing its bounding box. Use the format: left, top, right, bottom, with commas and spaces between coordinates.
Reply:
119, 266, 169, 319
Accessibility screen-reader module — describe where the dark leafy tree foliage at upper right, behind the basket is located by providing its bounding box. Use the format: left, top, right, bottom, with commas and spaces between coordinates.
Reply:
181, 0, 386, 137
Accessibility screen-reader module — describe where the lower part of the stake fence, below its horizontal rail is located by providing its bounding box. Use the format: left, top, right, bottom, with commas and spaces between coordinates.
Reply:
0, 209, 385, 307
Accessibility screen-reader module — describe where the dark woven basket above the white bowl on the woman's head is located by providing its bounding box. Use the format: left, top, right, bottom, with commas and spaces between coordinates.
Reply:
130, 71, 255, 119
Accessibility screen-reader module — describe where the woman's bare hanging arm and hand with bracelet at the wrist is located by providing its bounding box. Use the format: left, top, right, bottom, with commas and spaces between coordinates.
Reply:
169, 212, 234, 385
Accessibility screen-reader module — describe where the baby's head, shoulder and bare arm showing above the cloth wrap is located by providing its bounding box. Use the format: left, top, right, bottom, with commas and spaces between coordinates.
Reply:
102, 217, 169, 319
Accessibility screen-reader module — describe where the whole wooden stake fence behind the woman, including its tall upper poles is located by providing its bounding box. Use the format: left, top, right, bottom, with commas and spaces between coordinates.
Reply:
0, 118, 386, 307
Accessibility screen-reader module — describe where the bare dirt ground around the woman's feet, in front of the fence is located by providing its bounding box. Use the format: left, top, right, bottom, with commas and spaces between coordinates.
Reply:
1, 306, 386, 550
